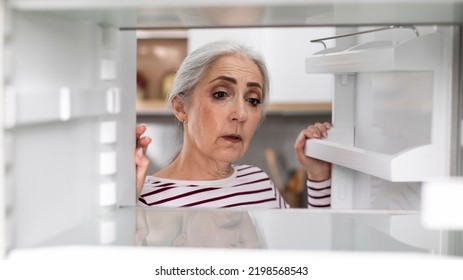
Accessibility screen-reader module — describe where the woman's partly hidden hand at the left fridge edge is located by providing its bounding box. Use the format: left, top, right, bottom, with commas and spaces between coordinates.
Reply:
135, 124, 151, 200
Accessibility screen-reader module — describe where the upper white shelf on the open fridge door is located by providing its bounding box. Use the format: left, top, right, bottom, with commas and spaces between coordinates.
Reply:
305, 29, 438, 74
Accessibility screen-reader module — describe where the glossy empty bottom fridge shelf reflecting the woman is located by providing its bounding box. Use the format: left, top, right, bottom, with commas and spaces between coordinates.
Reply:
5, 207, 446, 258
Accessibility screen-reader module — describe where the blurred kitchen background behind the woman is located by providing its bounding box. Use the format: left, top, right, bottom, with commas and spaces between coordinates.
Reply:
136, 27, 335, 207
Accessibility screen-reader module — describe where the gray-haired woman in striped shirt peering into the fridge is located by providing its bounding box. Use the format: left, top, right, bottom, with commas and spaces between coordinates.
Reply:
136, 41, 331, 208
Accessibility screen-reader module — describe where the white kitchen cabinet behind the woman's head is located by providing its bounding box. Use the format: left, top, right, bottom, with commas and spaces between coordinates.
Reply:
188, 27, 335, 103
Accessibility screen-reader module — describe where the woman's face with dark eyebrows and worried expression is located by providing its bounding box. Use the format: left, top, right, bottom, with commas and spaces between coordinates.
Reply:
185, 54, 264, 163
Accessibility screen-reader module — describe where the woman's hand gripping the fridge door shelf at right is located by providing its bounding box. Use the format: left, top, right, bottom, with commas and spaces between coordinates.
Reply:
294, 122, 331, 181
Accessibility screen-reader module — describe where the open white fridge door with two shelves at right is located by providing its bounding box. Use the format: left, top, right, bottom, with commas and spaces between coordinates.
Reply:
306, 26, 457, 209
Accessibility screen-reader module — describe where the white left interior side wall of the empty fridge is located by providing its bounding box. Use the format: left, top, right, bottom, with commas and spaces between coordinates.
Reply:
4, 11, 136, 252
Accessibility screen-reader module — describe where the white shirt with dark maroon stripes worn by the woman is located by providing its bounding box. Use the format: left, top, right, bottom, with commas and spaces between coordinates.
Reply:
138, 165, 331, 208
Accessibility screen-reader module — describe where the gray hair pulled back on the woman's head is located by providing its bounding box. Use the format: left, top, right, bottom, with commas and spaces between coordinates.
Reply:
167, 41, 270, 115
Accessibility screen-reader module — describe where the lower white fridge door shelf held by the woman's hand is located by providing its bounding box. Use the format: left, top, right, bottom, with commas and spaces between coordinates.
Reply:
305, 139, 442, 182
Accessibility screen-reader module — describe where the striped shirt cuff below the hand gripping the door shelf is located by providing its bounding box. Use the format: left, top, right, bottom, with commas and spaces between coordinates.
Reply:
307, 179, 331, 208
